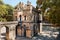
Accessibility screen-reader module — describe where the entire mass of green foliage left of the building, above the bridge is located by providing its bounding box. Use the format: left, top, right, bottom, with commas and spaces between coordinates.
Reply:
0, 0, 13, 21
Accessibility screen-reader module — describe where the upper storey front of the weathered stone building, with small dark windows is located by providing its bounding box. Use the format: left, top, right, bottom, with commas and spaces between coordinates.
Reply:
13, 1, 33, 21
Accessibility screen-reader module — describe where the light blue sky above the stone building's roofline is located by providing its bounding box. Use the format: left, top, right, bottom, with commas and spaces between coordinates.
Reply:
3, 0, 36, 7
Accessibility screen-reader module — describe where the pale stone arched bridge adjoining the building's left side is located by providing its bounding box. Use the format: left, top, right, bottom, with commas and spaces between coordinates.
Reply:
0, 21, 18, 40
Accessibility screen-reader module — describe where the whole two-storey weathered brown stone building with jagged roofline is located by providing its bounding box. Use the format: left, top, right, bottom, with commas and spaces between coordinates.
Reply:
13, 1, 38, 37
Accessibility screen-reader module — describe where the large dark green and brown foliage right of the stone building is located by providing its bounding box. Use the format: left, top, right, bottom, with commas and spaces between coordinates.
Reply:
37, 0, 60, 26
